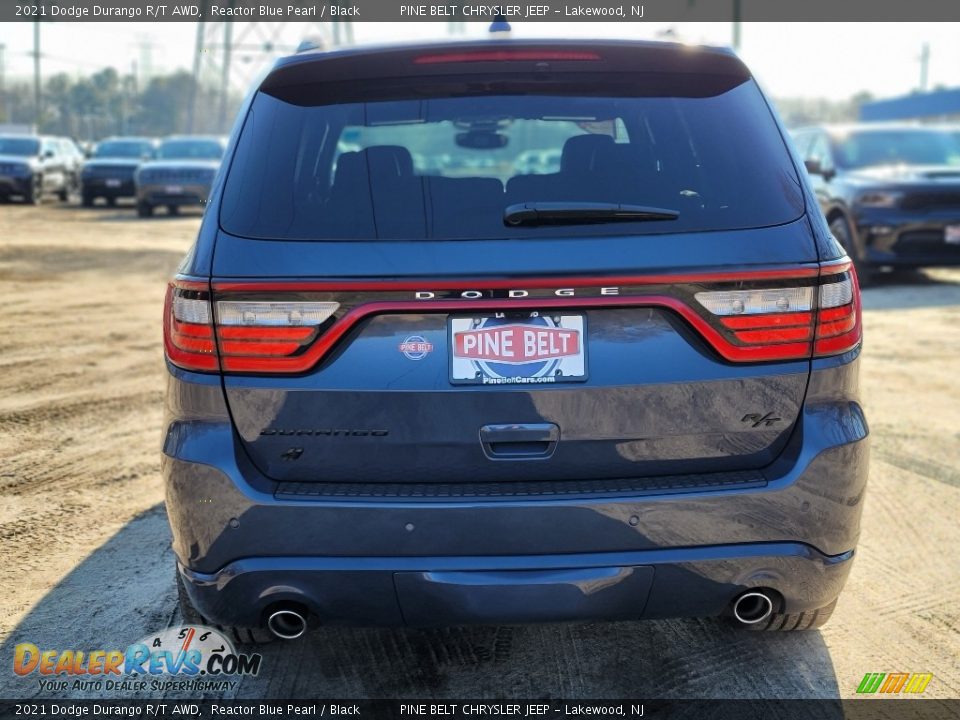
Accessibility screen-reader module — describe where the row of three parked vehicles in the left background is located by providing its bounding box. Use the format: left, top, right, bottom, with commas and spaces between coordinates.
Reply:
0, 135, 226, 217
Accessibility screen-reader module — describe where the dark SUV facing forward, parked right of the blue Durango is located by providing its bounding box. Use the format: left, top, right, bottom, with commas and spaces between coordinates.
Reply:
794, 124, 960, 283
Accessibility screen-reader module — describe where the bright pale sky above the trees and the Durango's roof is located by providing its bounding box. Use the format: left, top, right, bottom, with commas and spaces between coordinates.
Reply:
0, 22, 960, 99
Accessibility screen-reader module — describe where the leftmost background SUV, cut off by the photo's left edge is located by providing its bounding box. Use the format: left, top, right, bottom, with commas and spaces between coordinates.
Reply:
0, 135, 82, 204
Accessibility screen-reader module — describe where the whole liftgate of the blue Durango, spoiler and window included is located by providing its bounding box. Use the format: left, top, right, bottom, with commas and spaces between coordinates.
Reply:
195, 43, 832, 484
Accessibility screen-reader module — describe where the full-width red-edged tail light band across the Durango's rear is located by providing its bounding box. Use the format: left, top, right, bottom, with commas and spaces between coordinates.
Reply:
164, 262, 861, 374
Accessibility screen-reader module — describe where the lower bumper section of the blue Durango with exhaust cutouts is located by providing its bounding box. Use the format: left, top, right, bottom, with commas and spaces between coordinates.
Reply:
178, 543, 853, 627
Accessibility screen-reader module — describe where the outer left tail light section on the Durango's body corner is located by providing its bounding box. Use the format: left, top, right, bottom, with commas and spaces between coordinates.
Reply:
163, 280, 220, 372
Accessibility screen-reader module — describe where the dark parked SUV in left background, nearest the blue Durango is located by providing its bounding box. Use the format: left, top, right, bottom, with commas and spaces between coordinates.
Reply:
134, 135, 227, 217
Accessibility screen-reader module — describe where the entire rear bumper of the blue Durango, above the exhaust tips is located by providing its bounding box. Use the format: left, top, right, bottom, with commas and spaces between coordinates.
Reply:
163, 352, 868, 626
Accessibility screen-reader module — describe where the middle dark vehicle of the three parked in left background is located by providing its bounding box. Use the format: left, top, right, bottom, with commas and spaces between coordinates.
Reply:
80, 137, 159, 207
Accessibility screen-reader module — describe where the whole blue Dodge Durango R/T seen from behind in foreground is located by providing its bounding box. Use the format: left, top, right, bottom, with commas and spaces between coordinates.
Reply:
163, 41, 867, 640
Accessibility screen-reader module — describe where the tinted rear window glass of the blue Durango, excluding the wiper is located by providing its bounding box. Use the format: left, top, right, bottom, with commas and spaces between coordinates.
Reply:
220, 78, 803, 240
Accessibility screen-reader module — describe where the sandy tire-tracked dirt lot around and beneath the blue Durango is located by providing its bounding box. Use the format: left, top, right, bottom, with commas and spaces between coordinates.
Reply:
0, 203, 960, 699
